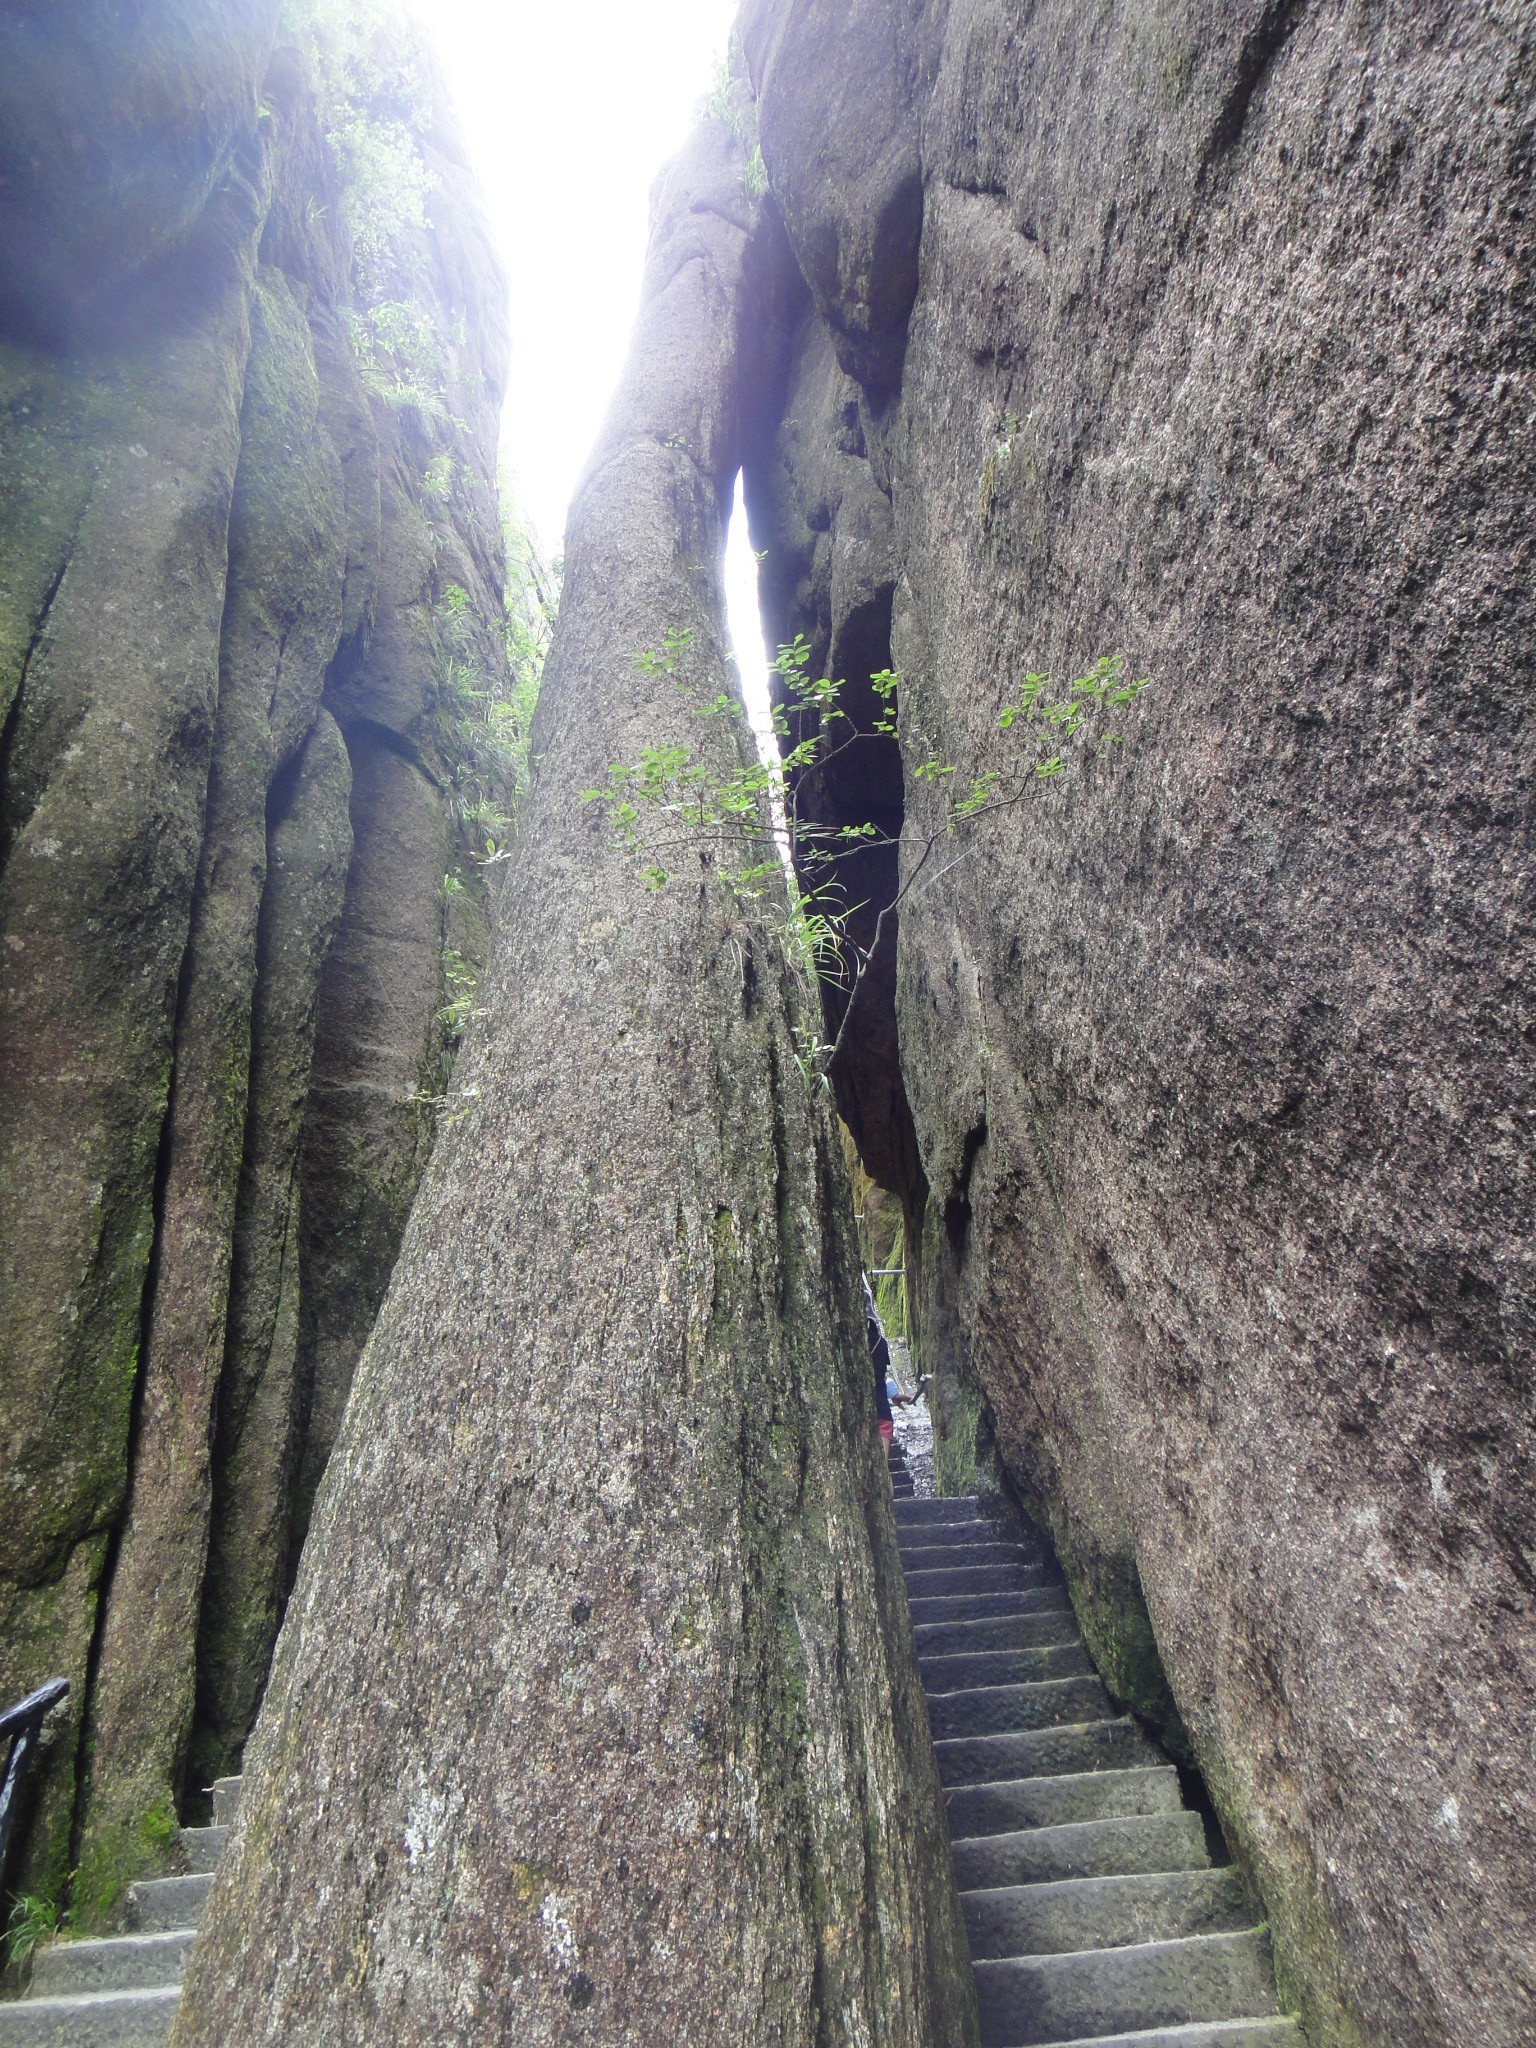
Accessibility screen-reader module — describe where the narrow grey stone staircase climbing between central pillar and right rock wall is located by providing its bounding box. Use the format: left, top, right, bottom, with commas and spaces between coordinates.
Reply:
891, 1490, 1305, 2048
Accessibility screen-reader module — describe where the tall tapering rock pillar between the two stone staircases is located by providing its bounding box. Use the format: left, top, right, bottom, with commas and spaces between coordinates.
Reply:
174, 127, 973, 2048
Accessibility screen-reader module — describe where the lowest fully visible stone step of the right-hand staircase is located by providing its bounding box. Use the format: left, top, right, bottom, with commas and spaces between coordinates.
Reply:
973, 1931, 1278, 2048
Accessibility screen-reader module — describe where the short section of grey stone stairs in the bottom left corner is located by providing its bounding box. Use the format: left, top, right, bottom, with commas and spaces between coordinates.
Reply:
0, 1778, 240, 2048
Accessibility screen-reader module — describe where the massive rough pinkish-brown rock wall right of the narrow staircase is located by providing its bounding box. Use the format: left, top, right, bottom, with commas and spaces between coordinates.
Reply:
743, 0, 1536, 2048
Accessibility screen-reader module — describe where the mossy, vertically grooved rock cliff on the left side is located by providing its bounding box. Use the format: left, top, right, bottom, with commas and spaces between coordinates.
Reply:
0, 0, 518, 1923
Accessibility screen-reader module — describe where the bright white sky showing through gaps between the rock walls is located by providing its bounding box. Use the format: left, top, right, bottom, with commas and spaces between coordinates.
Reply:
412, 0, 762, 720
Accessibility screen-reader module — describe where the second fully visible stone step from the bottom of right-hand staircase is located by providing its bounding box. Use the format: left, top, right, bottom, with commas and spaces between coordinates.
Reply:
961, 1870, 1253, 1962
